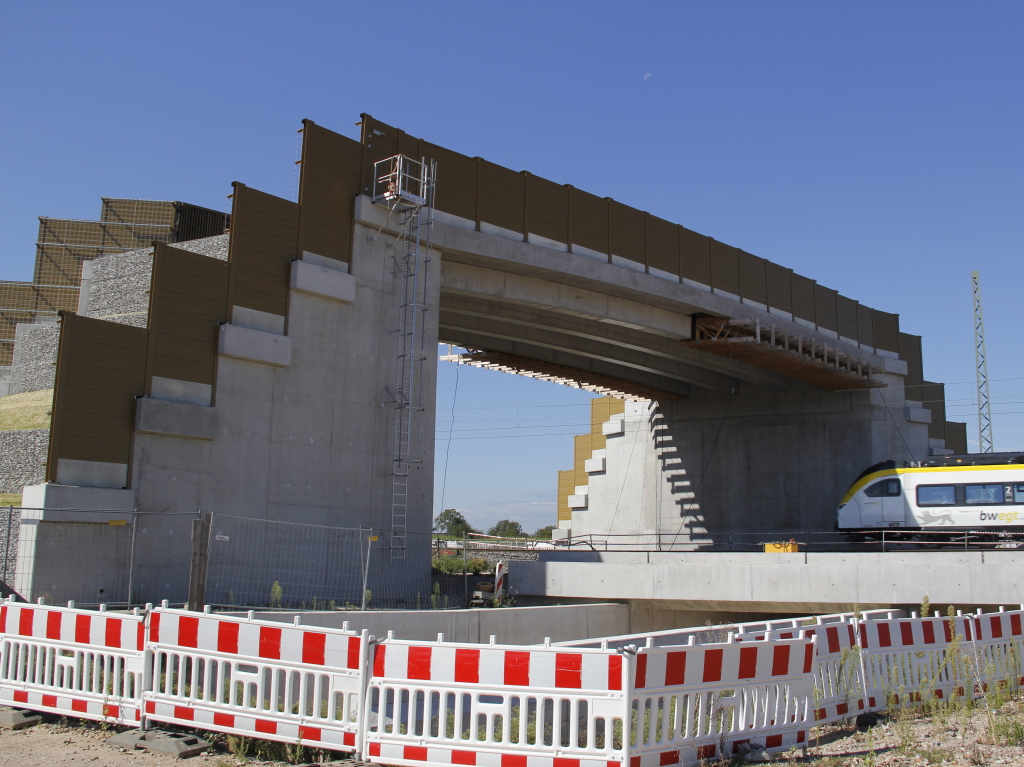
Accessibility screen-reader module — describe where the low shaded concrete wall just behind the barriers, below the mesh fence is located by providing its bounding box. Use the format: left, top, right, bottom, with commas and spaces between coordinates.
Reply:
247, 604, 630, 644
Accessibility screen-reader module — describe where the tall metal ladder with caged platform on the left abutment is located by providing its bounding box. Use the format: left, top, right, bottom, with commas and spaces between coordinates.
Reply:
373, 155, 437, 560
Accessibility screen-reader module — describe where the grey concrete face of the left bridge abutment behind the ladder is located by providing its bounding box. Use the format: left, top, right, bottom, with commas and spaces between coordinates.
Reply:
113, 217, 440, 601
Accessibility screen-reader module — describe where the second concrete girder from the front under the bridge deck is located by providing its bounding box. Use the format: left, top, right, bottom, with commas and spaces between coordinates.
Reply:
440, 291, 791, 391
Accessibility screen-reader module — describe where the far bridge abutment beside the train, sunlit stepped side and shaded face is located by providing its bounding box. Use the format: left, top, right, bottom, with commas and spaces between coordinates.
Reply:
571, 376, 929, 536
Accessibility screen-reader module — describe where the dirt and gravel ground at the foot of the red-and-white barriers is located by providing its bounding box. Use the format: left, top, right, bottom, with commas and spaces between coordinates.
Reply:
6, 701, 1024, 767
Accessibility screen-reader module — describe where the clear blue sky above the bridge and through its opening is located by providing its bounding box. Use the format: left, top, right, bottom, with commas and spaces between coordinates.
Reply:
0, 0, 1024, 526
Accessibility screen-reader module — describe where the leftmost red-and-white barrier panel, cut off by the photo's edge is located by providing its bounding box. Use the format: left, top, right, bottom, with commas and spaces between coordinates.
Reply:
0, 601, 145, 725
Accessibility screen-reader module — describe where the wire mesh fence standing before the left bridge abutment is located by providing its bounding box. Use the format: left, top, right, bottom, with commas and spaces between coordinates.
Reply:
0, 508, 520, 610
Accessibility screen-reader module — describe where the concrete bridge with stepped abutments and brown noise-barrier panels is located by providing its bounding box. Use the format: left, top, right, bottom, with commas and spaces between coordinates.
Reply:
0, 115, 966, 601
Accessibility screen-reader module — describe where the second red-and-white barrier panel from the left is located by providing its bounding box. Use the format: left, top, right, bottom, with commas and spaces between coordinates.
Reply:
145, 608, 367, 751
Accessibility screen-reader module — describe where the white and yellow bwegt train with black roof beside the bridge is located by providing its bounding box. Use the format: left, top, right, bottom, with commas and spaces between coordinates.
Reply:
837, 453, 1024, 542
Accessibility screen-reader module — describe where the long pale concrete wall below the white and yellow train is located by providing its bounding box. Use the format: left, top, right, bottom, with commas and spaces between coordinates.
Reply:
510, 550, 1024, 613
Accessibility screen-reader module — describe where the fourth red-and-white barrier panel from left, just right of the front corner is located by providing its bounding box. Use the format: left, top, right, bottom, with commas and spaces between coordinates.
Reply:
627, 637, 814, 767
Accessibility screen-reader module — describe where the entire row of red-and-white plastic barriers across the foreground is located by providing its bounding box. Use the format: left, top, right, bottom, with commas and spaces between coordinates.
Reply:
0, 600, 1024, 767
